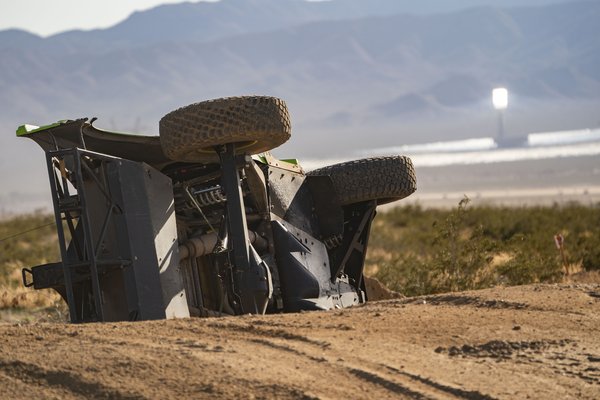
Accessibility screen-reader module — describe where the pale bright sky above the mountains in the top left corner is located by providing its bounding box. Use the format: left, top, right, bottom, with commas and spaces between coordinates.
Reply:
0, 0, 219, 36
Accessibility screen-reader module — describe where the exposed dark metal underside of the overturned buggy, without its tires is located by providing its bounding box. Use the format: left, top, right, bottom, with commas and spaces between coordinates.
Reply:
23, 120, 376, 322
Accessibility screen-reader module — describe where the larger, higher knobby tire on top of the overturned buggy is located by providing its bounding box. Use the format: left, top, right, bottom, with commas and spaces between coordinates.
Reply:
159, 96, 291, 162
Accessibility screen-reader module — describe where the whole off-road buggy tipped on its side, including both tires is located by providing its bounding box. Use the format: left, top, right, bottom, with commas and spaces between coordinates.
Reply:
17, 96, 416, 322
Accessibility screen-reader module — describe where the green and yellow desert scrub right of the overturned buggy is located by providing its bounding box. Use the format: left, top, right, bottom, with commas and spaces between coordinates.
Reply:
367, 199, 600, 295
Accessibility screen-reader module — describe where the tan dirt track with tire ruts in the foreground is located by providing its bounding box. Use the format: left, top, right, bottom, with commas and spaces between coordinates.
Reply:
0, 284, 600, 399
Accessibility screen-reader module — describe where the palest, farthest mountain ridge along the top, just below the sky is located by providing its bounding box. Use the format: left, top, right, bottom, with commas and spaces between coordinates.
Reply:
0, 0, 574, 49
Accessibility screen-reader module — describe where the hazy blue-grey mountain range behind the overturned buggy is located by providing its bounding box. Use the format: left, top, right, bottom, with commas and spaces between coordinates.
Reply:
0, 0, 600, 212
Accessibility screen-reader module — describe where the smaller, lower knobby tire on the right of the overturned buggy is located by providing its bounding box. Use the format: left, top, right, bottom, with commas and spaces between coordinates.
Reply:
307, 156, 417, 205
